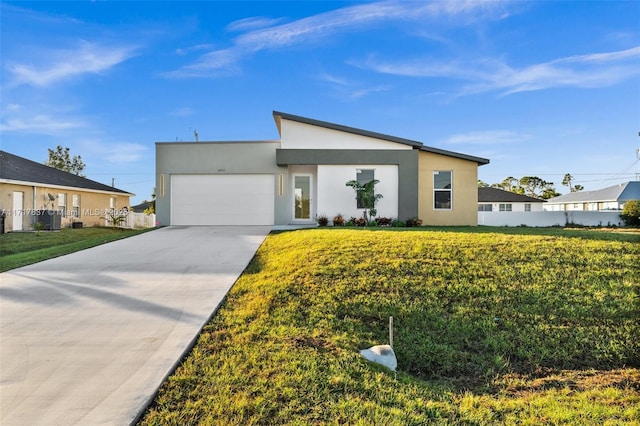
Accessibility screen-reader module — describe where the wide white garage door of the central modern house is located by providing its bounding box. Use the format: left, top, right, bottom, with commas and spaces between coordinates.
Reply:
171, 175, 274, 225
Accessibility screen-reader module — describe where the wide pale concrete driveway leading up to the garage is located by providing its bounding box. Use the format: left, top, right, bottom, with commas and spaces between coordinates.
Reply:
0, 226, 270, 426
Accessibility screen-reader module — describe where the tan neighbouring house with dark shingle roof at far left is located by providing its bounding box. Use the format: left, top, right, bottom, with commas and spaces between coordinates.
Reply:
0, 151, 135, 232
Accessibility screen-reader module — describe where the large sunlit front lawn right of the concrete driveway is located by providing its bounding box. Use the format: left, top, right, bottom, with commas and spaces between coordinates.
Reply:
141, 228, 640, 425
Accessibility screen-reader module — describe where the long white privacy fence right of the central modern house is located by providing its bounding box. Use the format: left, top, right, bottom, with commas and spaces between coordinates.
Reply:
478, 211, 624, 227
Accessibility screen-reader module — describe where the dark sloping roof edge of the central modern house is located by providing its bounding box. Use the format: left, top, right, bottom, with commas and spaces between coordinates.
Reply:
273, 111, 489, 165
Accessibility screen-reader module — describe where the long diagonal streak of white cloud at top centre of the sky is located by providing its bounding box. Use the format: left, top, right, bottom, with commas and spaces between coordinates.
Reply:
165, 0, 505, 77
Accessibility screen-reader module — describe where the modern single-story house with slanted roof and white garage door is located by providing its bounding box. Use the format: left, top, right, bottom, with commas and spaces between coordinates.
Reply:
156, 111, 489, 225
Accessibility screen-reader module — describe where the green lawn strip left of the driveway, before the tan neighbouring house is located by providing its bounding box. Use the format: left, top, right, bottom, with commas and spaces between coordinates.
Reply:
0, 228, 153, 272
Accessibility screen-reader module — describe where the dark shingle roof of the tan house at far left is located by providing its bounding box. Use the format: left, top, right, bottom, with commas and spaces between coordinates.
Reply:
0, 151, 133, 195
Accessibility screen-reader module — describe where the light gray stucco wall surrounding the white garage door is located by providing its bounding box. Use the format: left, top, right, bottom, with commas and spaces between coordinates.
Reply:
156, 141, 288, 225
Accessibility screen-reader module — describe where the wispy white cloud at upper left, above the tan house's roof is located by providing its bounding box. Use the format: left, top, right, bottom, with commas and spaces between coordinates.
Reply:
6, 42, 135, 87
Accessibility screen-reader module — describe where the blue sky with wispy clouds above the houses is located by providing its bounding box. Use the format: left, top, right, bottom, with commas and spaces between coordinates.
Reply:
0, 0, 640, 204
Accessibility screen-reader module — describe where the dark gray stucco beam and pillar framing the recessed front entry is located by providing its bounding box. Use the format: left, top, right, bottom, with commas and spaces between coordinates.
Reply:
276, 149, 418, 220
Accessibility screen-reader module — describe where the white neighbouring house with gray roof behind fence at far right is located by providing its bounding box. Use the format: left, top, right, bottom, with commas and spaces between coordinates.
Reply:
544, 181, 640, 211
